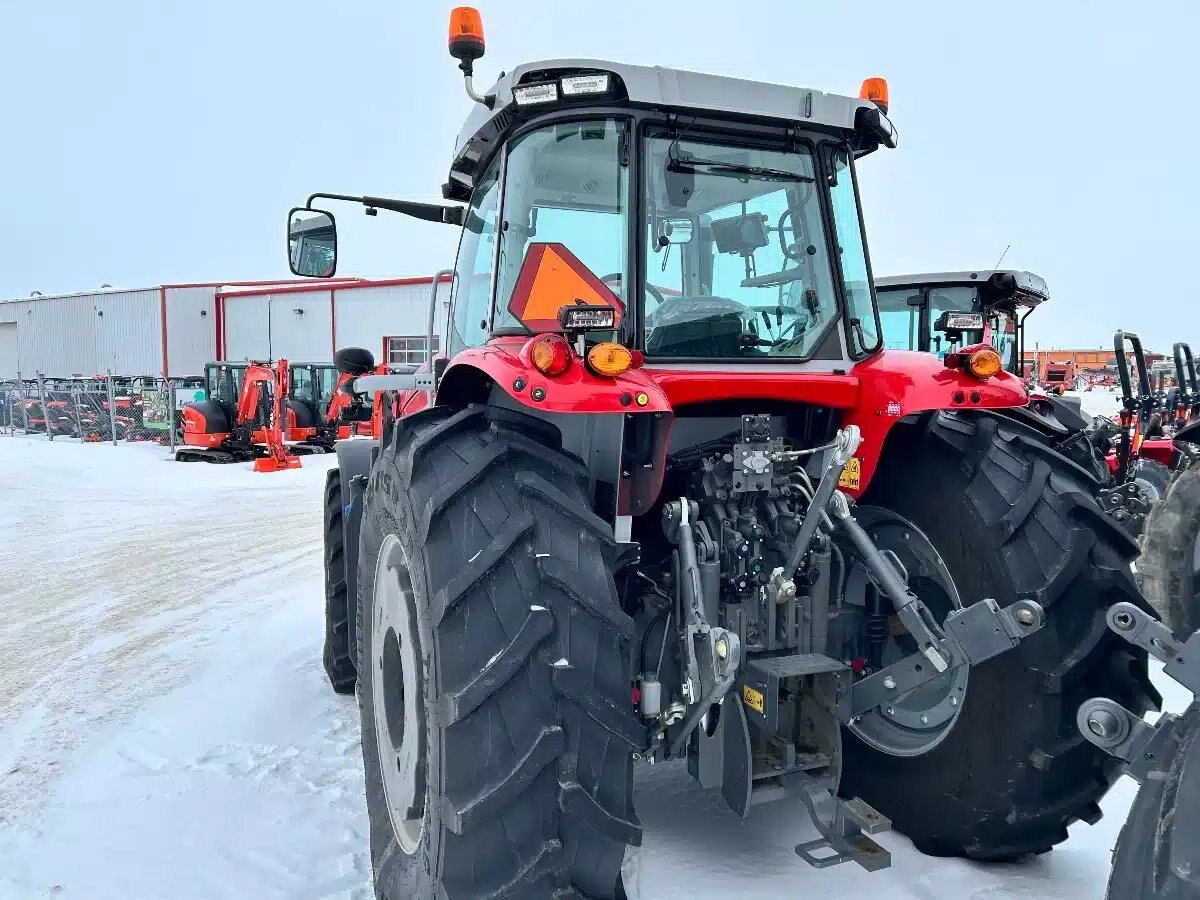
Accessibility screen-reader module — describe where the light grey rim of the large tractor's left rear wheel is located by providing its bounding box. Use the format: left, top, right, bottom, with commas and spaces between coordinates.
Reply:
371, 535, 426, 853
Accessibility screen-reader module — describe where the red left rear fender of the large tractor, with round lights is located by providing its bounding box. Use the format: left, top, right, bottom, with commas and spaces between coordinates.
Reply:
434, 337, 671, 415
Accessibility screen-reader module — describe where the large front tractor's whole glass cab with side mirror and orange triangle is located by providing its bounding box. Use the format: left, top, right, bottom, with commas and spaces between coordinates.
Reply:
289, 60, 896, 390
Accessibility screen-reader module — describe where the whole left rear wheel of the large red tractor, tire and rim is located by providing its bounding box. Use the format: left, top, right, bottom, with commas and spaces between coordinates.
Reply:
359, 407, 644, 900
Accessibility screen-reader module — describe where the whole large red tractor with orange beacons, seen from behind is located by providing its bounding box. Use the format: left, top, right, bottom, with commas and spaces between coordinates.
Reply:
289, 7, 1156, 900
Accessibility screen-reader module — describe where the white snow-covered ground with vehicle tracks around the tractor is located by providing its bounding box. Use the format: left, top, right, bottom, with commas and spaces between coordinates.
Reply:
0, 392, 1189, 900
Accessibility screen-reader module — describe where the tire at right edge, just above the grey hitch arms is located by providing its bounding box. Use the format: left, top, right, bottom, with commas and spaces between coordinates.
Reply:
1138, 466, 1200, 636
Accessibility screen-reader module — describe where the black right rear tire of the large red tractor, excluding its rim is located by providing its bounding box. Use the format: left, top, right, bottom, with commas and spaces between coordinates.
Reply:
841, 413, 1158, 859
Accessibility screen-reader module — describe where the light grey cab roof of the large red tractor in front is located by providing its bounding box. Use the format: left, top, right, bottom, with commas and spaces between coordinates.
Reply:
443, 59, 896, 200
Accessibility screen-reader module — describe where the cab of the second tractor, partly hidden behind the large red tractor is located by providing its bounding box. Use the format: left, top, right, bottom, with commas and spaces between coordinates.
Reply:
875, 270, 1050, 376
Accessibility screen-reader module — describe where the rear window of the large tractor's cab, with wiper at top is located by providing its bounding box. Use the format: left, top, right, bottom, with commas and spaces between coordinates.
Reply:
641, 136, 840, 359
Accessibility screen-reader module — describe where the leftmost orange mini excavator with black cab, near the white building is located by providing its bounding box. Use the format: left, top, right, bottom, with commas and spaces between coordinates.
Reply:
175, 359, 300, 472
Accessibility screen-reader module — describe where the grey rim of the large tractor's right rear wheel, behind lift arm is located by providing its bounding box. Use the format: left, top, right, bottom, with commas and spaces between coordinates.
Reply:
842, 506, 970, 756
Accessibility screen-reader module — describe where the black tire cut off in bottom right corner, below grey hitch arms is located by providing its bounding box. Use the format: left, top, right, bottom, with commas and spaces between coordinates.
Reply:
1108, 701, 1200, 900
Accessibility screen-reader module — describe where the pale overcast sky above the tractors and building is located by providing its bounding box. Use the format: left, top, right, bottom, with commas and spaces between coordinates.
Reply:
0, 0, 1200, 348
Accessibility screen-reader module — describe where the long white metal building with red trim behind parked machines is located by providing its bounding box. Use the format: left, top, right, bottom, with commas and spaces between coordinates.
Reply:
0, 277, 449, 378
